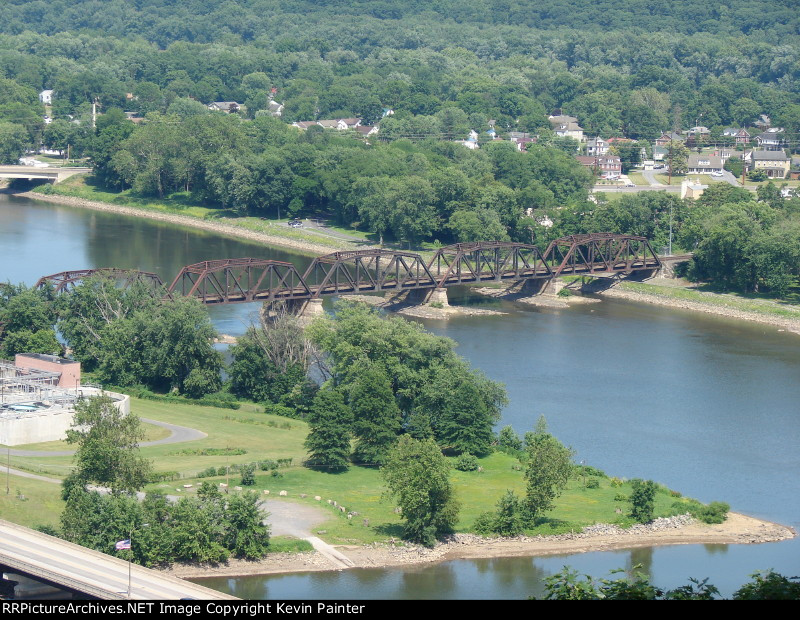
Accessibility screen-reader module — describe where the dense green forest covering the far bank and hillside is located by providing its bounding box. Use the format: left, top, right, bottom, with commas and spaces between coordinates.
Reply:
0, 0, 800, 292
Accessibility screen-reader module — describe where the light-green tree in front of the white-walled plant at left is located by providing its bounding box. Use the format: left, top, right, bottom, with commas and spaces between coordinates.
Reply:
67, 395, 151, 494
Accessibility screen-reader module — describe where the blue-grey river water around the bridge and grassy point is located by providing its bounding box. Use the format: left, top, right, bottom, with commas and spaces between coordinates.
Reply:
0, 195, 800, 599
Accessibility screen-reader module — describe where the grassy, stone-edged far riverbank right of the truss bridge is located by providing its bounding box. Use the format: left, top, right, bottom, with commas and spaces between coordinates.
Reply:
598, 278, 800, 334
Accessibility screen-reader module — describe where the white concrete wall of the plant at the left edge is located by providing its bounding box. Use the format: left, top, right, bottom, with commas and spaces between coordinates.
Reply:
0, 388, 131, 446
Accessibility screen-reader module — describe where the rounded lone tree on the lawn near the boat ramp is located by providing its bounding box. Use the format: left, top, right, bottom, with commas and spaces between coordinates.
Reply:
381, 435, 460, 547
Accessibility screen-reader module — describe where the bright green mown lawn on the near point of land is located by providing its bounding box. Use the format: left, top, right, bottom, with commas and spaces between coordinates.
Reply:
0, 398, 700, 543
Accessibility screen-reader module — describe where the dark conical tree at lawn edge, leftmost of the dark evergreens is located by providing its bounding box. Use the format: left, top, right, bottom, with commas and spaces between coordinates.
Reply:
305, 389, 353, 472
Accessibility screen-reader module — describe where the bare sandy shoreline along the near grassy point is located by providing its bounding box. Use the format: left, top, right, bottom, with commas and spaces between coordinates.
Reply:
166, 512, 796, 579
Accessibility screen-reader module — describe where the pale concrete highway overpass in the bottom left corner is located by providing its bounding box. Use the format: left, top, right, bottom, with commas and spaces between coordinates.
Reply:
0, 520, 236, 600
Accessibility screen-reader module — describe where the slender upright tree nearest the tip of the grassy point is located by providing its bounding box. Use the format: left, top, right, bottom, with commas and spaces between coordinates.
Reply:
525, 418, 575, 521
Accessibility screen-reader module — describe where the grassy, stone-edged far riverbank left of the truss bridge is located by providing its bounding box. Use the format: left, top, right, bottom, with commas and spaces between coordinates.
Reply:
13, 191, 364, 256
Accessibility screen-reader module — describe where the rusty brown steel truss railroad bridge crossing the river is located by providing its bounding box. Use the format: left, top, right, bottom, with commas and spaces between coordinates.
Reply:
36, 233, 661, 304
